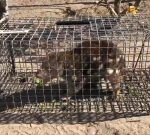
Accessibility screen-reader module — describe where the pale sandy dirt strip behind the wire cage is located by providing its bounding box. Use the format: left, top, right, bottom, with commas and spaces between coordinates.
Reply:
8, 0, 115, 18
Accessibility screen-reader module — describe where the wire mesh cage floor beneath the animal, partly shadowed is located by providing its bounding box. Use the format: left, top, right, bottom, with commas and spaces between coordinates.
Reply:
0, 70, 150, 113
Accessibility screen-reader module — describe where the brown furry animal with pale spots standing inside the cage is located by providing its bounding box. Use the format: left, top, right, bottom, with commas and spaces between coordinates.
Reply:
36, 40, 125, 98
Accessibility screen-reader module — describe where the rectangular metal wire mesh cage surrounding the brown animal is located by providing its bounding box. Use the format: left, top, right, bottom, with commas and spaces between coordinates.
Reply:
0, 14, 150, 117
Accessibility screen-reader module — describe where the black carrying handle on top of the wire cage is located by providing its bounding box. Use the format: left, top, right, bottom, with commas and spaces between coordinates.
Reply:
56, 20, 90, 25
